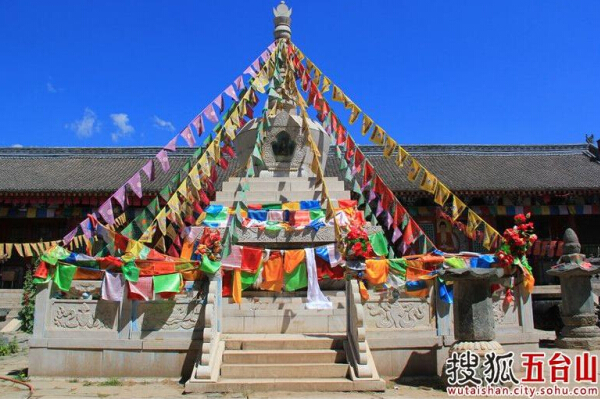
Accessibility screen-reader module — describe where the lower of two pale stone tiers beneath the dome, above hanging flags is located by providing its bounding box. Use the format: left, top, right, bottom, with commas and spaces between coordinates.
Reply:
215, 190, 350, 203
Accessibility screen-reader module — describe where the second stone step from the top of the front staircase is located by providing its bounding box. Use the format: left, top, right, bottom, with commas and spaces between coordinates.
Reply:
223, 349, 346, 367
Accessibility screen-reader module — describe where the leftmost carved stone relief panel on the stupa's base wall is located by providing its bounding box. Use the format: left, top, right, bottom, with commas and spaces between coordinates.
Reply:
50, 300, 119, 330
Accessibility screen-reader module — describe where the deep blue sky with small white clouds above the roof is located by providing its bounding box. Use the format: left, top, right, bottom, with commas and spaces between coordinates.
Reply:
0, 0, 600, 146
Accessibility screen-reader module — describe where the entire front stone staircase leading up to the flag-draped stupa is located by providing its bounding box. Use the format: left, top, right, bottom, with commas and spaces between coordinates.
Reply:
185, 291, 385, 393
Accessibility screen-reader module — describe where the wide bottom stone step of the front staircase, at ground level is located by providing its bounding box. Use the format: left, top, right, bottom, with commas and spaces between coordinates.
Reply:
185, 378, 385, 393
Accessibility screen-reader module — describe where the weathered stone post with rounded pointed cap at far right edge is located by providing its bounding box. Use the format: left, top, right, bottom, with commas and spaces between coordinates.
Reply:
546, 229, 600, 350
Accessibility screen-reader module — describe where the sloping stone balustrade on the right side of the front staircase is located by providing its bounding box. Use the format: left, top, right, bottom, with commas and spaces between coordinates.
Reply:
346, 279, 373, 378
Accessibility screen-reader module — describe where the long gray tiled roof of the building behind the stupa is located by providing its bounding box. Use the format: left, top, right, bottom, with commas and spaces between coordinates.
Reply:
0, 144, 600, 193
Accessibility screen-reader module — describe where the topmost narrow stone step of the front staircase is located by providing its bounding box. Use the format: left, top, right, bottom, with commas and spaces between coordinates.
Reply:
223, 334, 346, 350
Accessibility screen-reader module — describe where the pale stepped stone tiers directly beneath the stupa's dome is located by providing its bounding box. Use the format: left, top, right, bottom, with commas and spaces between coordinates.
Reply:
212, 177, 350, 206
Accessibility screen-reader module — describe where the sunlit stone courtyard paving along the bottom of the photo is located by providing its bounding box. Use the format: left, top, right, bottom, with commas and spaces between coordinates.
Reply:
0, 333, 600, 399
